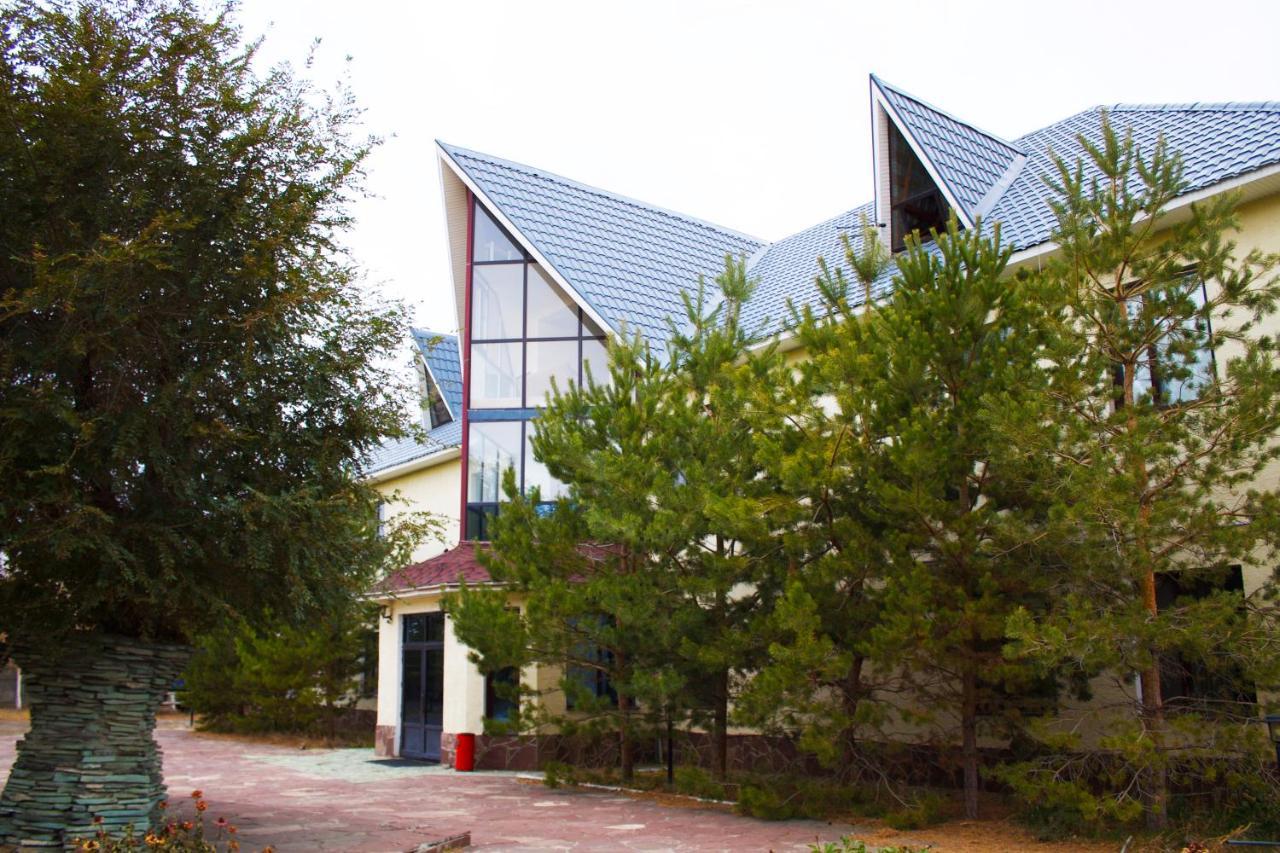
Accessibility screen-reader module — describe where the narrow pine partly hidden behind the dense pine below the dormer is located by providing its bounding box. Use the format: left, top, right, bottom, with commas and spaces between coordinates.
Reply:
736, 220, 893, 776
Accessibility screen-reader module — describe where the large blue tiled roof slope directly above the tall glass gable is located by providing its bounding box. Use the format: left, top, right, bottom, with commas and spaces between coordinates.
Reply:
440, 142, 764, 346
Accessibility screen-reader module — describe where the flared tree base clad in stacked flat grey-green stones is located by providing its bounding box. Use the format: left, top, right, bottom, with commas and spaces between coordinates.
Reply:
0, 634, 189, 849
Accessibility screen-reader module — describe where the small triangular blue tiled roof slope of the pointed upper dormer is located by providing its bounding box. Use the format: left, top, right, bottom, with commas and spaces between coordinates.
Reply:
872, 76, 1024, 220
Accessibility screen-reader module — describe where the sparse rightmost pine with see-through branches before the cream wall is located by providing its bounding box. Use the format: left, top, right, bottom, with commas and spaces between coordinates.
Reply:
1005, 115, 1280, 827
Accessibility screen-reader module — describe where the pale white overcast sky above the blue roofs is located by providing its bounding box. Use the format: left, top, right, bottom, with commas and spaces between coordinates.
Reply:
239, 0, 1280, 332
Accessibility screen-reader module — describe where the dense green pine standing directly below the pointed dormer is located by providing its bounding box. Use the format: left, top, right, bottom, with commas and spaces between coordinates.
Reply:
865, 218, 1052, 818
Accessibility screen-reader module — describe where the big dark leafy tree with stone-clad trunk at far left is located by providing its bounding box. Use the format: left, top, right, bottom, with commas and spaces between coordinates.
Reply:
0, 0, 403, 844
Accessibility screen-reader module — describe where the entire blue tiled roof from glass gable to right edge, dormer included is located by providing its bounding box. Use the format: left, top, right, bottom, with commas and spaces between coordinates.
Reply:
442, 87, 1280, 346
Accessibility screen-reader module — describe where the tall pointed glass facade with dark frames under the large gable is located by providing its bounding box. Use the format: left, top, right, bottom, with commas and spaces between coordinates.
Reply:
465, 202, 608, 540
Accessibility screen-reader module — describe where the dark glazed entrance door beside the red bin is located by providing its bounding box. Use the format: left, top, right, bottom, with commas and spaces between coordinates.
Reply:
401, 613, 444, 761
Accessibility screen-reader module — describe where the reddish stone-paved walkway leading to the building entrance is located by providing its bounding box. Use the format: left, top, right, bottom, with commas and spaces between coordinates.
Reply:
0, 726, 852, 853
